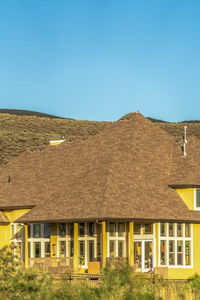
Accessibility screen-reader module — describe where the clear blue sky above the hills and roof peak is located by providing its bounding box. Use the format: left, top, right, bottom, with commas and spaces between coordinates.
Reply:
0, 0, 200, 121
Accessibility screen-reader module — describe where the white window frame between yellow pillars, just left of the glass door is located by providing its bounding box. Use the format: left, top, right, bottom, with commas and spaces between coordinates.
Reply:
107, 221, 127, 258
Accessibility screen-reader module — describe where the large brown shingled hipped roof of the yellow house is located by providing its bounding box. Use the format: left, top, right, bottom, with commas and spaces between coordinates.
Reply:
0, 113, 200, 222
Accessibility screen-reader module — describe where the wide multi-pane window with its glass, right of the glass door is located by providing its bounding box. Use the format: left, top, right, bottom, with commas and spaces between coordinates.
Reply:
159, 223, 192, 267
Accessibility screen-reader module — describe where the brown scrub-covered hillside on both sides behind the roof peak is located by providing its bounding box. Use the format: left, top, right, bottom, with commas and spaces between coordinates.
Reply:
0, 113, 200, 165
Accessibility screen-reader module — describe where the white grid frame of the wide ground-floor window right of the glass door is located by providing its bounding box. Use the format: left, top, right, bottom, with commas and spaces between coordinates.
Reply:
158, 223, 193, 269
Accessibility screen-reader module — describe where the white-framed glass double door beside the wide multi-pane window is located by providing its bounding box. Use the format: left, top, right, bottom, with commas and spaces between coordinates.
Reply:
134, 240, 153, 272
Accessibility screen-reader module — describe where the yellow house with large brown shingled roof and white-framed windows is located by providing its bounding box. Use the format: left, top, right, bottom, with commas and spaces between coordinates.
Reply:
0, 113, 200, 279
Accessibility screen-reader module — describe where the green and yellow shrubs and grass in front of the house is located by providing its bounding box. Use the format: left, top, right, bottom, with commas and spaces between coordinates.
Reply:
0, 247, 200, 300
